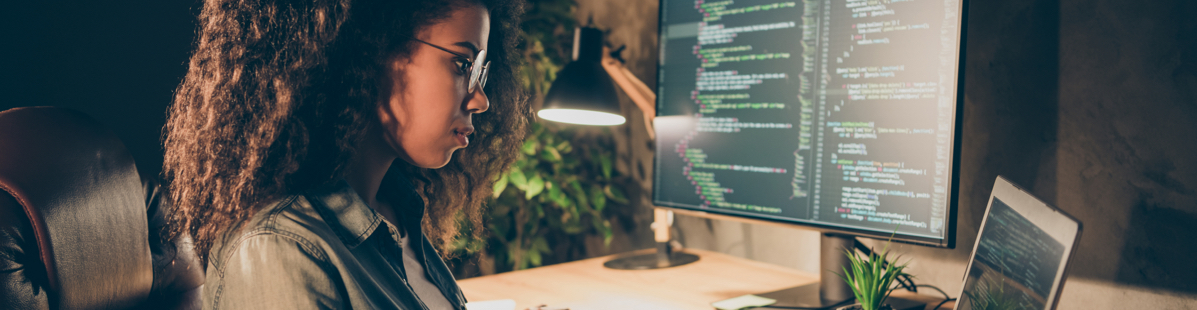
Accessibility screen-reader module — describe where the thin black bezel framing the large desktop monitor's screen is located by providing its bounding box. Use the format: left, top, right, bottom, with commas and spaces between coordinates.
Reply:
651, 0, 968, 249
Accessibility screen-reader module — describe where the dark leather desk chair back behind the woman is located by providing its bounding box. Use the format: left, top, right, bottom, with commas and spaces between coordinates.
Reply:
0, 107, 203, 309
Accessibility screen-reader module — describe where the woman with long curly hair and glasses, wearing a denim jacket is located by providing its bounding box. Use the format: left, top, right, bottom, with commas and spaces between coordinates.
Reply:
163, 0, 530, 309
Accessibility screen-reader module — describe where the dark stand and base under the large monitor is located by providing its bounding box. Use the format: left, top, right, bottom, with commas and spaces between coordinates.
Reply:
757, 233, 926, 310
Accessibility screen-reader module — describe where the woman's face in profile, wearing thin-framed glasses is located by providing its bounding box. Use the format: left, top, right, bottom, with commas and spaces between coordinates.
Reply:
378, 5, 491, 169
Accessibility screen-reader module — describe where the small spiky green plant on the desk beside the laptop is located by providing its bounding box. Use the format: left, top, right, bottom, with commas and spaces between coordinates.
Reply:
839, 241, 909, 310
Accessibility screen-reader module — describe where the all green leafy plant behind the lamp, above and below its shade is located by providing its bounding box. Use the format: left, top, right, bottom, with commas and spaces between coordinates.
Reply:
450, 0, 630, 278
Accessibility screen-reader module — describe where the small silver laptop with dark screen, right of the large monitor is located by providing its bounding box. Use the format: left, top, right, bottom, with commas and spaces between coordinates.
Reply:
955, 176, 1081, 310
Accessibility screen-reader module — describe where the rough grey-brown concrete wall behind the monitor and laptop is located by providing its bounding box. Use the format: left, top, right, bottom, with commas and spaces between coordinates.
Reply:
577, 0, 1197, 309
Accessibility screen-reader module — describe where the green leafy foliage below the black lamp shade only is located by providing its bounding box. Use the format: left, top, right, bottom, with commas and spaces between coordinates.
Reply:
487, 124, 627, 269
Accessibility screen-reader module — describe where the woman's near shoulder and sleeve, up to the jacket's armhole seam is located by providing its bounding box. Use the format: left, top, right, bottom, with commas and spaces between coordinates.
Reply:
203, 196, 348, 309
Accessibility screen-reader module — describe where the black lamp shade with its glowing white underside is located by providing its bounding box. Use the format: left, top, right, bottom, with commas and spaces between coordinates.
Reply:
536, 28, 625, 126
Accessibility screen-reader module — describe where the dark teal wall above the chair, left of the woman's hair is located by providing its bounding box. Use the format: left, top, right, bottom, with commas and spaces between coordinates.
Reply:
0, 0, 200, 179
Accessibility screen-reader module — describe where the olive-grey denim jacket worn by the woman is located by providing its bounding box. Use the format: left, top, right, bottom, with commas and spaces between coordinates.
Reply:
203, 175, 466, 310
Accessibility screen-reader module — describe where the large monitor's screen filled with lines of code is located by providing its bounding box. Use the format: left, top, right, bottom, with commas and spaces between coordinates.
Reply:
654, 0, 964, 247
